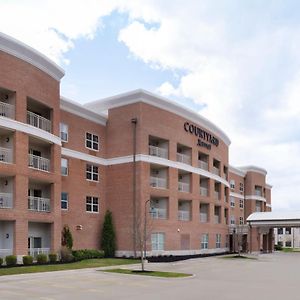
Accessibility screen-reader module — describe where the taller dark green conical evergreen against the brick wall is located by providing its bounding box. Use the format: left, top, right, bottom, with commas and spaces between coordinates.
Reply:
101, 210, 116, 257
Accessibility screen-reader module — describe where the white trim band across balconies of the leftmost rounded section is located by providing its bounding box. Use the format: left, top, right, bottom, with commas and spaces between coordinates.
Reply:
0, 117, 61, 146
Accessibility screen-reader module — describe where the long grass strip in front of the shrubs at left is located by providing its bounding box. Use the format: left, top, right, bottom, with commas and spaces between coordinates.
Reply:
0, 258, 139, 276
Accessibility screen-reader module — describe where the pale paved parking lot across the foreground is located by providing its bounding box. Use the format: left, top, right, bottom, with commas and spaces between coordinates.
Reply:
0, 253, 300, 300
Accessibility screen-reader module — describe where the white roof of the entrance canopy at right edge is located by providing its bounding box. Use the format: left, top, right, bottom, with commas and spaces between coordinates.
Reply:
247, 211, 300, 227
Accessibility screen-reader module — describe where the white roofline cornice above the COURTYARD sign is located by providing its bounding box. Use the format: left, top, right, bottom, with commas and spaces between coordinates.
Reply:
84, 89, 231, 146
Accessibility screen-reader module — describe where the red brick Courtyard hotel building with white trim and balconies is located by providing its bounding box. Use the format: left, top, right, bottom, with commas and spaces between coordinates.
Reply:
0, 34, 273, 257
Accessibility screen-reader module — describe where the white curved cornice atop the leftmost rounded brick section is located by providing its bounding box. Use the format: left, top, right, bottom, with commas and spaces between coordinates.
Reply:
0, 32, 65, 81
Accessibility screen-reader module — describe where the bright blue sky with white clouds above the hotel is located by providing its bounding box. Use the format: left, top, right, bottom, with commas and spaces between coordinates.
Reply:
0, 0, 300, 211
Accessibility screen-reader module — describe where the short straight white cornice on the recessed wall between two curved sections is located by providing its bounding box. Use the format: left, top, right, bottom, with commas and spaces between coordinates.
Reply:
60, 97, 107, 126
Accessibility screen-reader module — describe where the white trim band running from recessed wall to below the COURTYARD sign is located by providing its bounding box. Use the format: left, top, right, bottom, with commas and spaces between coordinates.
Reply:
61, 147, 229, 187
